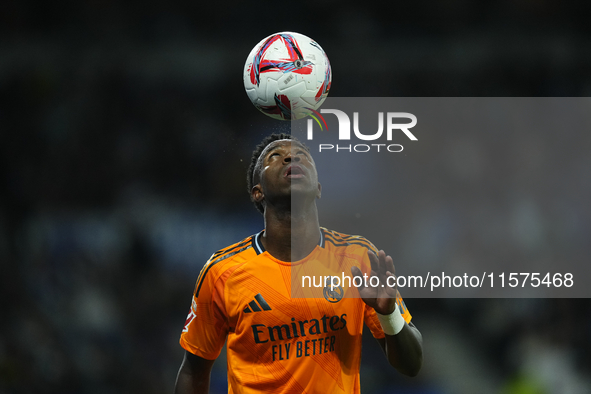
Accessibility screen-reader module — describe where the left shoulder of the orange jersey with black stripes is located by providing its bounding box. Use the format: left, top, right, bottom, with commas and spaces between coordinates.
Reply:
194, 234, 258, 297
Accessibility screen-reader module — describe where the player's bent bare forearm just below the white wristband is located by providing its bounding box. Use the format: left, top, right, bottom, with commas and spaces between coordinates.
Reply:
384, 324, 423, 376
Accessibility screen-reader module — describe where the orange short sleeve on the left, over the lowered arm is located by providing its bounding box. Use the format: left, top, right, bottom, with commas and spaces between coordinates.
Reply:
180, 265, 228, 360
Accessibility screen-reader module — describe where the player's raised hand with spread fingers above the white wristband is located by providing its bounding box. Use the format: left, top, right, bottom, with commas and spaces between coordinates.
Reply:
351, 250, 398, 315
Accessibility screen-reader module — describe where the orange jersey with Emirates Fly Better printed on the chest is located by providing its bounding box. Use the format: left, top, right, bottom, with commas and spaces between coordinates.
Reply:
180, 228, 411, 394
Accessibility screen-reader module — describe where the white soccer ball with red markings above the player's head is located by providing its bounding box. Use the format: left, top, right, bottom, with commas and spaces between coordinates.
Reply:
244, 32, 332, 120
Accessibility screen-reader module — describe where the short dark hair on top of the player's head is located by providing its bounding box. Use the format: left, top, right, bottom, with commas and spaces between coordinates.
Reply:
246, 133, 319, 213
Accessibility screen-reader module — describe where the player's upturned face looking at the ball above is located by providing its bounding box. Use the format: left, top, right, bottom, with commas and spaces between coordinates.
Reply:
252, 140, 321, 211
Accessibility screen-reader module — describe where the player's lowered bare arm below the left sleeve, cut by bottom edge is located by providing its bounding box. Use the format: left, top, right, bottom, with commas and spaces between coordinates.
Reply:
174, 352, 215, 394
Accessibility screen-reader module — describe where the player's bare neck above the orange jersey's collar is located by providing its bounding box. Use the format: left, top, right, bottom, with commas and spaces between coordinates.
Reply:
261, 203, 320, 262
